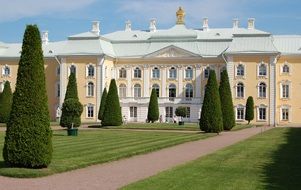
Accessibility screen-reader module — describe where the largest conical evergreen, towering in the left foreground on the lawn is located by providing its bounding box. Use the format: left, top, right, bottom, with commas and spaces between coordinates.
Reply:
3, 25, 52, 168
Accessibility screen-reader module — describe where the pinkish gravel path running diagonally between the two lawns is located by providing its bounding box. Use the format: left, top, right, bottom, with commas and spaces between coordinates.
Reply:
0, 127, 271, 190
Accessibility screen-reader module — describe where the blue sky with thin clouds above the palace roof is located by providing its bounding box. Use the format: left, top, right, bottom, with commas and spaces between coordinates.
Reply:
0, 0, 301, 42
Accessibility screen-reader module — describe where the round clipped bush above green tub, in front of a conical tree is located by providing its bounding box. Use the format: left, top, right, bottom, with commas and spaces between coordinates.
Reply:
61, 98, 83, 129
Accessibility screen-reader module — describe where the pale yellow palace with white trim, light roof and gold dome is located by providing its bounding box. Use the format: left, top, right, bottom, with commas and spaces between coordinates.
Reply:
0, 8, 301, 125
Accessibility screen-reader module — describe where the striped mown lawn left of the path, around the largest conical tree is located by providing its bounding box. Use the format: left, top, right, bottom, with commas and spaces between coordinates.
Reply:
0, 130, 215, 177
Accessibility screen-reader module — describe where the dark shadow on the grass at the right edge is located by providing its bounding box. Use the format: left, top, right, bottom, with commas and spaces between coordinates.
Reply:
263, 128, 301, 190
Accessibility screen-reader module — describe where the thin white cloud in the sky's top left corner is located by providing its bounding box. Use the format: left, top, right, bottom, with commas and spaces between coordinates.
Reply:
0, 0, 96, 22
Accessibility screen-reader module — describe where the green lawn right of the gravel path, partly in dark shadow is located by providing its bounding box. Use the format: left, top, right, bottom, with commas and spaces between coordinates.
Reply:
123, 128, 301, 190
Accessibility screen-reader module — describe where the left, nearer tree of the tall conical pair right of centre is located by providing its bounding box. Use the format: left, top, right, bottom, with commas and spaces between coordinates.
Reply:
200, 70, 223, 133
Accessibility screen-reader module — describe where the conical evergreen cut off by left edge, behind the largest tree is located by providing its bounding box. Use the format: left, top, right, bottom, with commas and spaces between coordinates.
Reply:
0, 81, 13, 123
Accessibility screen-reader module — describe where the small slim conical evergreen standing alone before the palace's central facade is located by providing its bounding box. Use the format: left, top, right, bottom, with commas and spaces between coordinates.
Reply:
147, 89, 159, 123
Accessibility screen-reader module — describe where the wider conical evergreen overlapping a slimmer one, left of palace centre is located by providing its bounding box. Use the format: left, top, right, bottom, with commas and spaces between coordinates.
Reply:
101, 79, 122, 126
